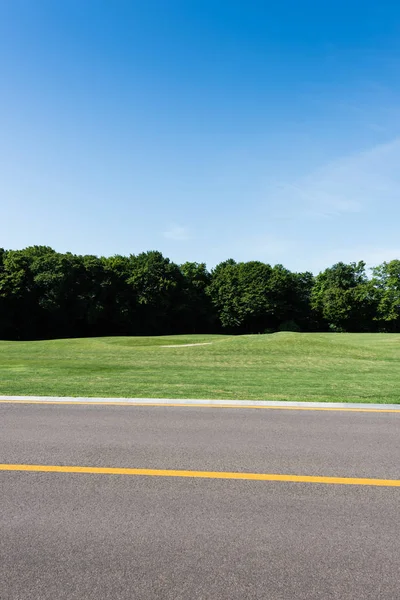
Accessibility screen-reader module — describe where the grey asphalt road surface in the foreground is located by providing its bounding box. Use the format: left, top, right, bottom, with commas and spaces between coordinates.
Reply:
0, 404, 400, 600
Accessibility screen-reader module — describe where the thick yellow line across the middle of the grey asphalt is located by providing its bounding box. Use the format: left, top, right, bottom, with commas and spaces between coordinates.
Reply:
0, 464, 400, 487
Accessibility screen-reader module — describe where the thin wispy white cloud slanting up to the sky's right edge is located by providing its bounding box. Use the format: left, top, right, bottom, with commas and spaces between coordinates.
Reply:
271, 138, 400, 218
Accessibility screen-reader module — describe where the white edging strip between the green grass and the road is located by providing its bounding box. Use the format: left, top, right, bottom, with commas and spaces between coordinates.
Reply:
0, 396, 400, 412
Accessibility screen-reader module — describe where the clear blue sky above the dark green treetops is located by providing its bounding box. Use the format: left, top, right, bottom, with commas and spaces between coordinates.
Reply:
0, 0, 400, 272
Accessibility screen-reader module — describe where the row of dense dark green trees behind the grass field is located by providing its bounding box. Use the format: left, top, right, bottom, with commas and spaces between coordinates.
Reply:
0, 246, 400, 340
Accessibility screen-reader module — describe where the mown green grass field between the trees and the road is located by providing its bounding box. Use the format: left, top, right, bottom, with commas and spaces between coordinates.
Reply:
0, 333, 400, 403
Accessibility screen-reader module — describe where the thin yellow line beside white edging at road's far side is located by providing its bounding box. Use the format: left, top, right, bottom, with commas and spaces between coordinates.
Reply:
0, 400, 400, 413
